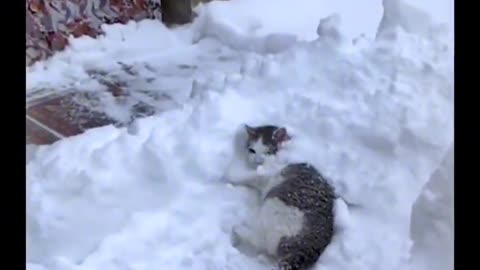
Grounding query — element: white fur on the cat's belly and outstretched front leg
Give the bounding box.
[226,158,304,256]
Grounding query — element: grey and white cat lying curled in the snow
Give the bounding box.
[225,125,336,270]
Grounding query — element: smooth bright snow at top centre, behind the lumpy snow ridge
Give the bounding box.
[198,0,383,40]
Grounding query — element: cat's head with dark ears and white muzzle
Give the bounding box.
[245,125,291,166]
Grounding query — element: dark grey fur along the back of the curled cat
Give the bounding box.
[265,163,335,270]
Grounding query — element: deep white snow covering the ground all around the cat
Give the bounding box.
[27,0,453,270]
